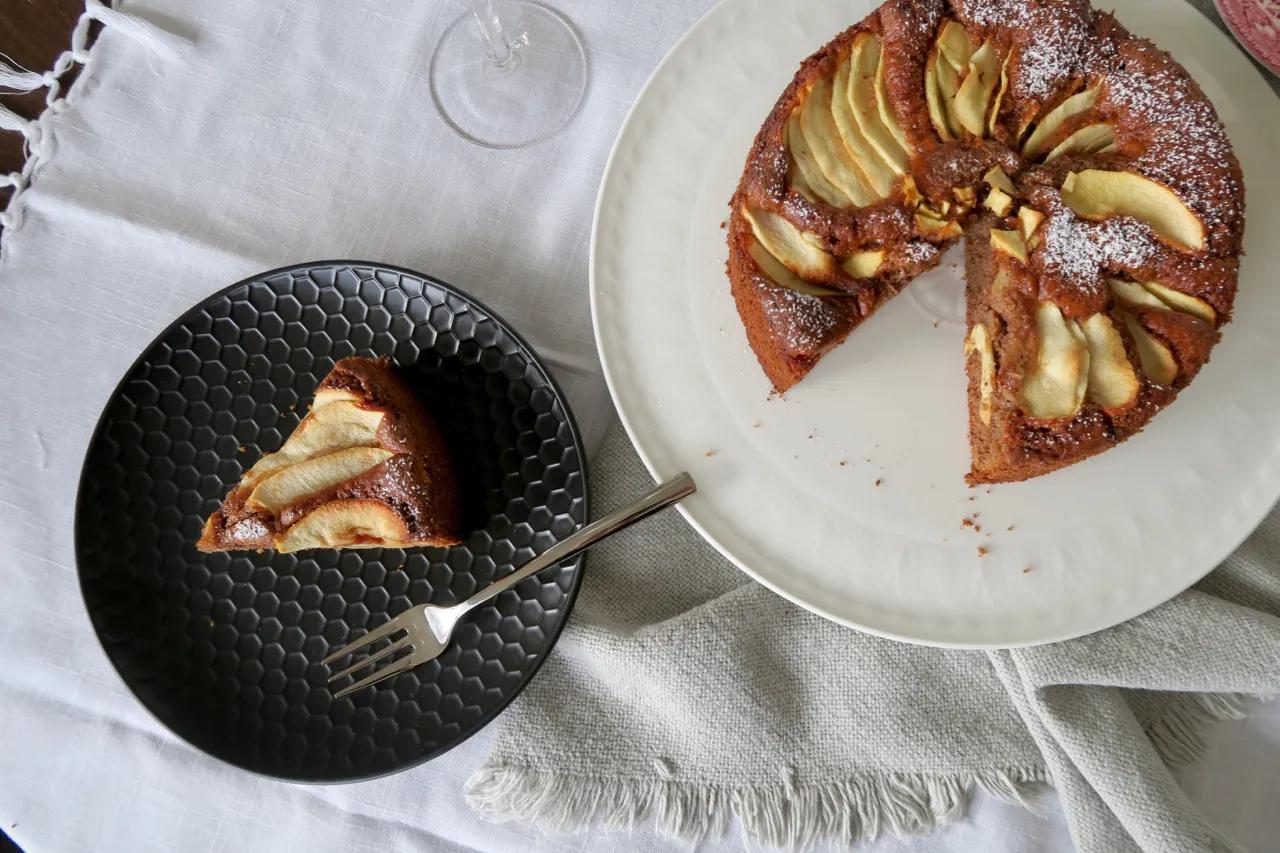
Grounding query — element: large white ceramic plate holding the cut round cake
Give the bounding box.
[591,0,1280,647]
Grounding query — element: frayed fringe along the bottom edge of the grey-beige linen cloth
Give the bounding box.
[467,762,1047,849]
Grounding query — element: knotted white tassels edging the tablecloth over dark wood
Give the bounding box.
[0,0,191,236]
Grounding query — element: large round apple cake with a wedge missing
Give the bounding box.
[727,0,1244,483]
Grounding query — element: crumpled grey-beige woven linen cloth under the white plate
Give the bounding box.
[470,429,1280,850]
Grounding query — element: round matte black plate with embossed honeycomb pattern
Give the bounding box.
[76,261,588,781]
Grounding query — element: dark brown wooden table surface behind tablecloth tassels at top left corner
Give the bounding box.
[0,0,84,207]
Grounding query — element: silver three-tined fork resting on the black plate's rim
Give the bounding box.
[324,471,698,698]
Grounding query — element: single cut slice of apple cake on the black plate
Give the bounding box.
[197,359,461,552]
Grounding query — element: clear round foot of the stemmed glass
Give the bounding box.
[430,0,588,149]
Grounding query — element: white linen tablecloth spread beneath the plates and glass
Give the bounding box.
[0,0,1280,853]
